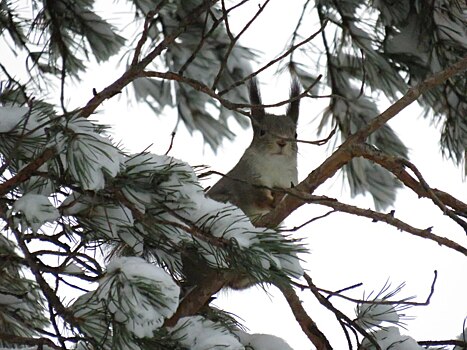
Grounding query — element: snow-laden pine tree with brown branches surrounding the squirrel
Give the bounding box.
[0,0,467,350]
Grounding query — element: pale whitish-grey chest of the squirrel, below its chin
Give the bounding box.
[254,155,298,188]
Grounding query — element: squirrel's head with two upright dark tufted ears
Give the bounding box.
[249,79,300,156]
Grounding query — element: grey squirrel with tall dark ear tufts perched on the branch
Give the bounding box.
[207,79,300,221]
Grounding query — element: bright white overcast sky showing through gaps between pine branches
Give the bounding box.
[1,1,467,350]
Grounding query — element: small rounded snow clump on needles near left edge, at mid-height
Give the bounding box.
[10,193,60,232]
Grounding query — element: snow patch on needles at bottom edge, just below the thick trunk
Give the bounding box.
[170,316,245,350]
